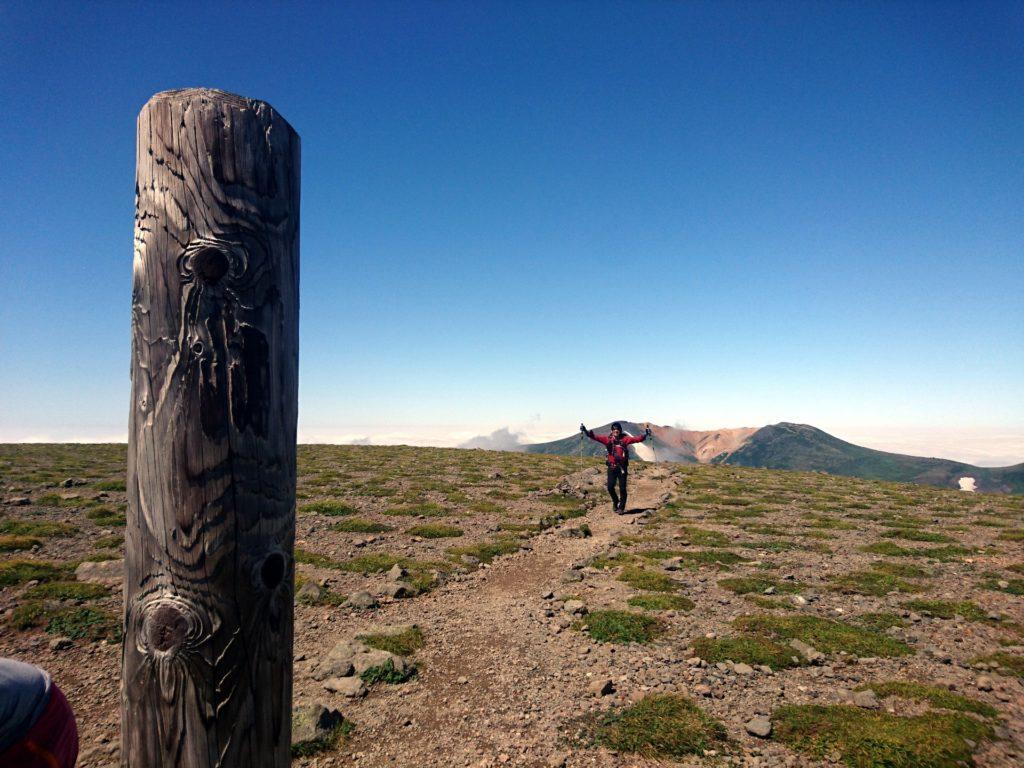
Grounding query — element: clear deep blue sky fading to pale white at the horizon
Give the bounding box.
[0,1,1024,463]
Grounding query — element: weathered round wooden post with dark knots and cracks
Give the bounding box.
[121,88,299,768]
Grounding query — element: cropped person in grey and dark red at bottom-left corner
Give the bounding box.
[0,657,78,768]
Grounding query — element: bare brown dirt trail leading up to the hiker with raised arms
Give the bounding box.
[309,473,672,766]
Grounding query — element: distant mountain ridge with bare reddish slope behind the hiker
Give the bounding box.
[523,420,1024,494]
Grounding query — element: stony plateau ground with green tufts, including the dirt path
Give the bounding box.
[0,445,1024,768]
